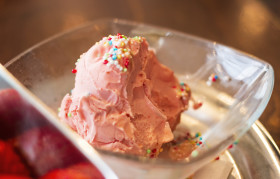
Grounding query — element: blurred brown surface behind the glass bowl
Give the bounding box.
[0,0,280,146]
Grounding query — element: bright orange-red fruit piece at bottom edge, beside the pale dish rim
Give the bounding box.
[40,163,104,179]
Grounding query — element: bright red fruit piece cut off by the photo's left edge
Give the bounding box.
[0,140,29,178]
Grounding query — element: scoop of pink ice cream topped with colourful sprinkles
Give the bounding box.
[59,34,190,156]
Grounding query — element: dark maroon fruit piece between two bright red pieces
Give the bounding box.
[17,126,87,176]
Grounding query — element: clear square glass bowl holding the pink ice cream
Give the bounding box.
[5,19,274,178]
